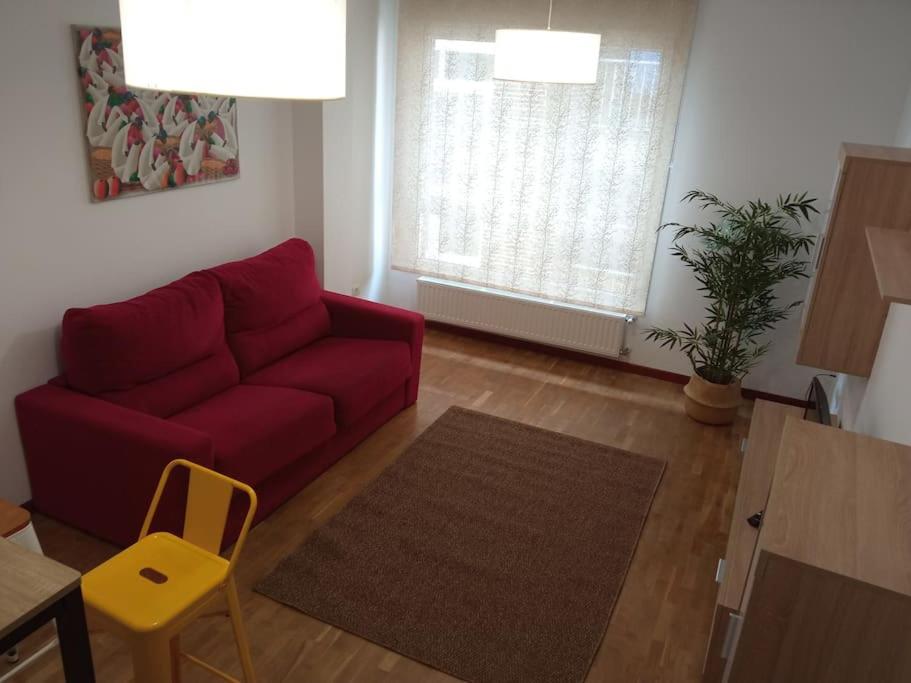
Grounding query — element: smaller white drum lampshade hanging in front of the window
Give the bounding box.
[493,28,601,84]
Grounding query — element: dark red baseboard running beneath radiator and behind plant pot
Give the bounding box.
[424,320,807,408]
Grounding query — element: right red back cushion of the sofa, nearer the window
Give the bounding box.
[209,239,329,375]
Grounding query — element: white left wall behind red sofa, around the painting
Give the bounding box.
[0,0,294,502]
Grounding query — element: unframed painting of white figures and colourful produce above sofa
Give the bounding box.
[73,27,240,202]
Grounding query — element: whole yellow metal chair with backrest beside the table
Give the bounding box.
[82,460,256,683]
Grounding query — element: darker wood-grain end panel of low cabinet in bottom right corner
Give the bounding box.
[728,550,911,683]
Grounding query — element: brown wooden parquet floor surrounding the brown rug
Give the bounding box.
[8,331,750,683]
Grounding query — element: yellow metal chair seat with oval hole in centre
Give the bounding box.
[82,533,228,633]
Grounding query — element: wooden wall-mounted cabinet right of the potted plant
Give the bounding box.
[797,143,911,377]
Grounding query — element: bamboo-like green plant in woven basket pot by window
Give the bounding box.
[646,190,819,424]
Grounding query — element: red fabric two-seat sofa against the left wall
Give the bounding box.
[16,239,424,545]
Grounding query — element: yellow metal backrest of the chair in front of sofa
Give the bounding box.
[139,459,256,574]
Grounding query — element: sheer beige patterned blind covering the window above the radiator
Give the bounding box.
[392,0,696,314]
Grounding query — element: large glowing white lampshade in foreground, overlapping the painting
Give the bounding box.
[120,0,345,100]
